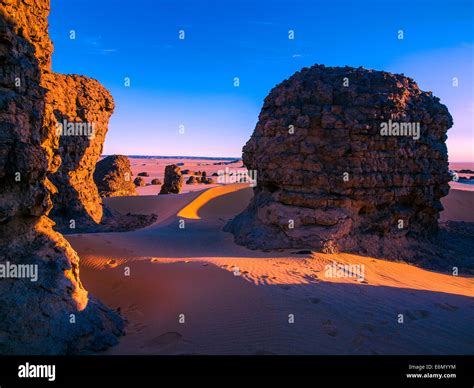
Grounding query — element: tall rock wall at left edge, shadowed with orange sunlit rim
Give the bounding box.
[0,0,123,354]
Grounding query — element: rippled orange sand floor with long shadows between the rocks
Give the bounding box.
[67,164,474,354]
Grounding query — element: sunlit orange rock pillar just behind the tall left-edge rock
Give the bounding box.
[45,73,114,230]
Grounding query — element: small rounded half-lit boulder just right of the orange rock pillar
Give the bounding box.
[94,155,137,197]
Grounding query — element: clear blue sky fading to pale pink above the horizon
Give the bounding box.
[49,0,474,162]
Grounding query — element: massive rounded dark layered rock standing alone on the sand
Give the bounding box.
[226,65,452,257]
